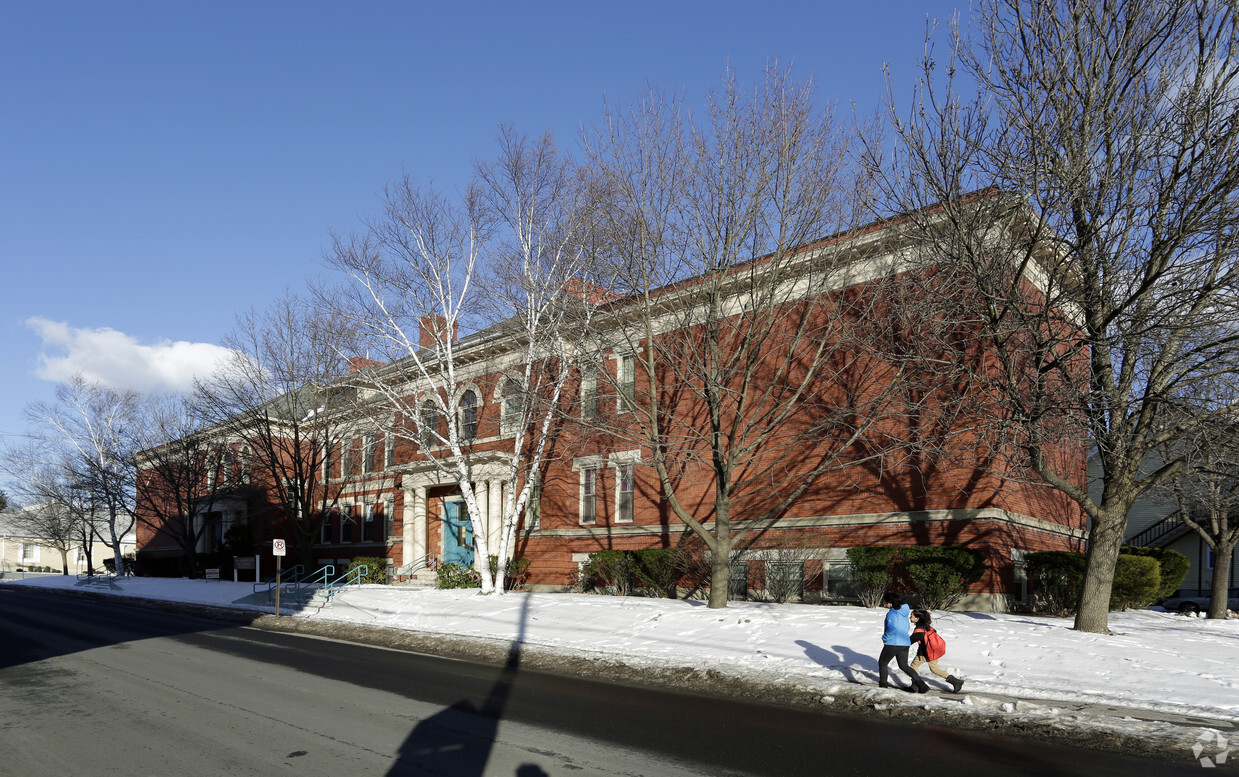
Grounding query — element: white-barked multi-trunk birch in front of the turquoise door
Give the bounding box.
[328,126,592,594]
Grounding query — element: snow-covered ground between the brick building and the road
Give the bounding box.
[0,575,1239,765]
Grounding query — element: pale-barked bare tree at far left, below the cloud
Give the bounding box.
[19,374,142,571]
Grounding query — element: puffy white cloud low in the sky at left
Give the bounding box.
[26,316,229,392]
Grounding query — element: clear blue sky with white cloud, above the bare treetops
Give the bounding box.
[0,0,966,493]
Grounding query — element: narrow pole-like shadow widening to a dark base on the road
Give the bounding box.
[387,597,546,777]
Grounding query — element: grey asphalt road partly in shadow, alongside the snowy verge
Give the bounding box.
[0,586,1199,777]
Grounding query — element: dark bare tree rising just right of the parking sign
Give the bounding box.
[195,294,370,564]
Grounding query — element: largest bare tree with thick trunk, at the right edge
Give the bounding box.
[871,0,1239,632]
